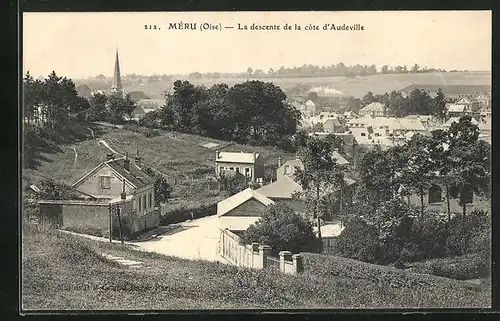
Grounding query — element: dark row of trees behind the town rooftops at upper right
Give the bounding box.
[347,89,446,120]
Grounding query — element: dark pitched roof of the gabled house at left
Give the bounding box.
[72,157,154,188]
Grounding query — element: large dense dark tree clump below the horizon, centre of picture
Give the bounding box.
[141,80,300,147]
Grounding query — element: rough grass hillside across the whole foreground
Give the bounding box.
[21,224,491,310]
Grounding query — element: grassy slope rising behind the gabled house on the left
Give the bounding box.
[23,127,292,198]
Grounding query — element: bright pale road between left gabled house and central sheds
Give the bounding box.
[135,216,227,263]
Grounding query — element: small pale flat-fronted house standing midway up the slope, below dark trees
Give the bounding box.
[215,150,264,182]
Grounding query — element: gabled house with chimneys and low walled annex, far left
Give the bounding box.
[38,153,160,235]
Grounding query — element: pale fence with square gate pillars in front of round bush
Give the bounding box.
[220,229,303,274]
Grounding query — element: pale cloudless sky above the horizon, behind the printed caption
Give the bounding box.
[23,11,492,78]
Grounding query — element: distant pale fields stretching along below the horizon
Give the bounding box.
[75,72,491,99]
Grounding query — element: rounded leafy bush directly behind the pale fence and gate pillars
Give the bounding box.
[242,203,317,255]
